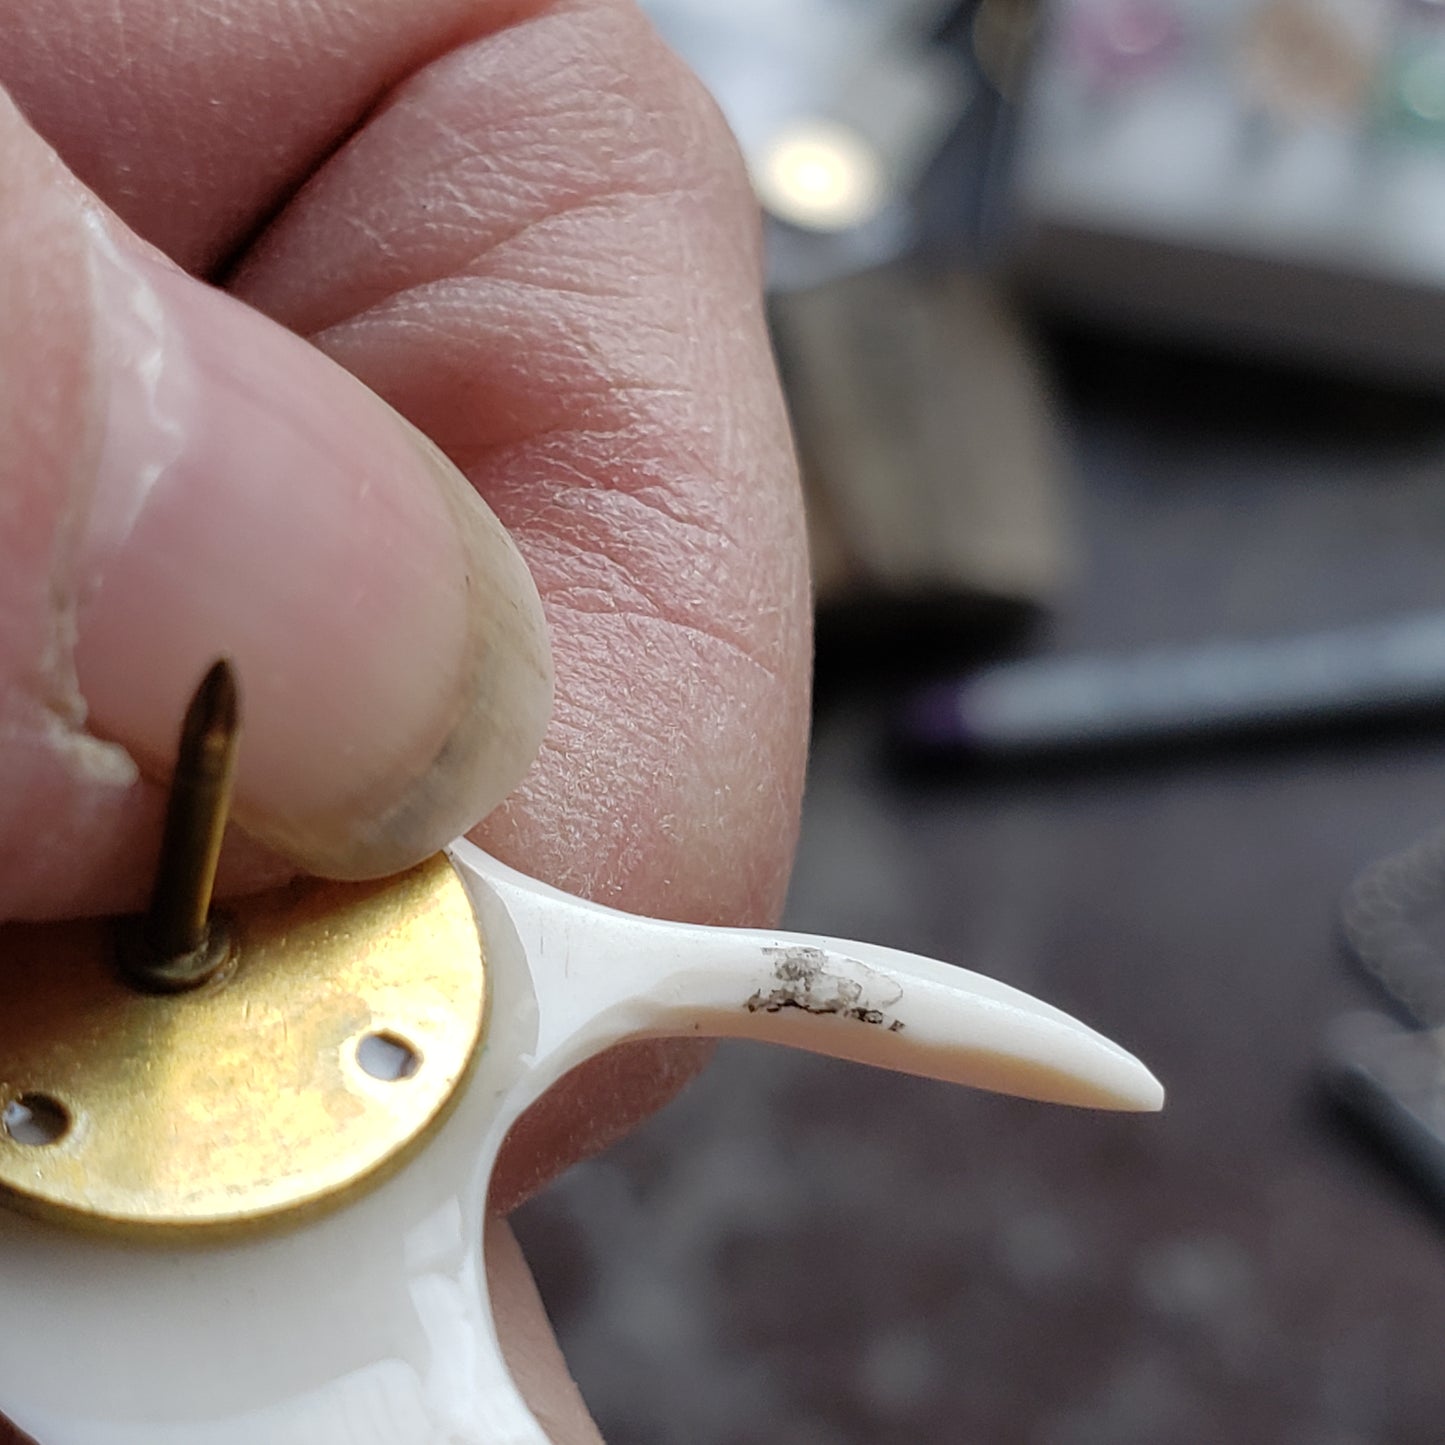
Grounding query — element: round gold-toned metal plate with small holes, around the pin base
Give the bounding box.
[0,854,487,1238]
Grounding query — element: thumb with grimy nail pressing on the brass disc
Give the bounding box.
[0,94,551,918]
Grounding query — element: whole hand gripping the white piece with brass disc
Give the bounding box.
[0,0,808,1445]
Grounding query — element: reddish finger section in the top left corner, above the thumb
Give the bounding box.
[0,0,508,275]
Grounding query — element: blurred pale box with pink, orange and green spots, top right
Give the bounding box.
[1005,0,1445,386]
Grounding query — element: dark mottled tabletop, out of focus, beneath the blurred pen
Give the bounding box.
[519,330,1445,1445]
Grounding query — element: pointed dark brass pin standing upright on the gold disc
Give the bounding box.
[121,657,240,993]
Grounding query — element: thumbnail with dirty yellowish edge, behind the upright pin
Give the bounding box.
[67,223,552,877]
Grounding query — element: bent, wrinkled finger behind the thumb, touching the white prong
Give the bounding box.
[225,6,808,1207]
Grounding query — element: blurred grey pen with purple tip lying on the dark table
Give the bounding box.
[900,613,1445,756]
